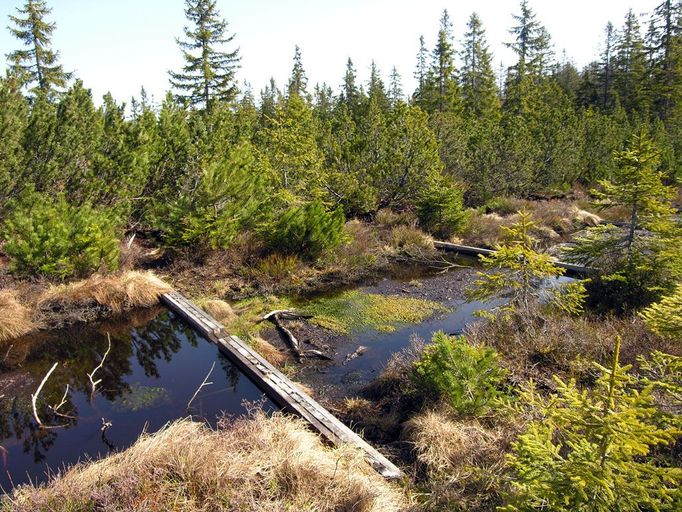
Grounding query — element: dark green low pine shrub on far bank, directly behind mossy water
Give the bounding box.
[265,201,345,260]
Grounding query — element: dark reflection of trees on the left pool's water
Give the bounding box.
[0,308,194,463]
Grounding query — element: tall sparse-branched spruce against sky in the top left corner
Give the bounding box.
[7,0,71,93]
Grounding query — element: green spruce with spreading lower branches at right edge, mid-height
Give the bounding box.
[566,131,682,310]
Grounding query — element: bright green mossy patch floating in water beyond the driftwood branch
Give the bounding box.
[303,290,447,334]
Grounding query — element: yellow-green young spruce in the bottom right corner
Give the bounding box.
[500,338,682,512]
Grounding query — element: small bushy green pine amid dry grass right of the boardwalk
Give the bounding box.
[414,331,506,415]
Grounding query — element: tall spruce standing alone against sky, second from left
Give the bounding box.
[169,0,240,109]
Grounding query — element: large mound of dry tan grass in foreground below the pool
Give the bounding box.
[5,413,407,512]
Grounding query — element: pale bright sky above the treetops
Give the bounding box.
[0,0,661,106]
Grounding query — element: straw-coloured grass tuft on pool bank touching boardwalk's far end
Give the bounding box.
[39,271,171,314]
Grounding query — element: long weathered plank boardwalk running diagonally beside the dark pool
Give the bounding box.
[161,292,403,479]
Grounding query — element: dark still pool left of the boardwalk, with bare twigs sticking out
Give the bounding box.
[0,308,275,491]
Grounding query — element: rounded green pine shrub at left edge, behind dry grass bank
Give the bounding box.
[0,189,120,279]
